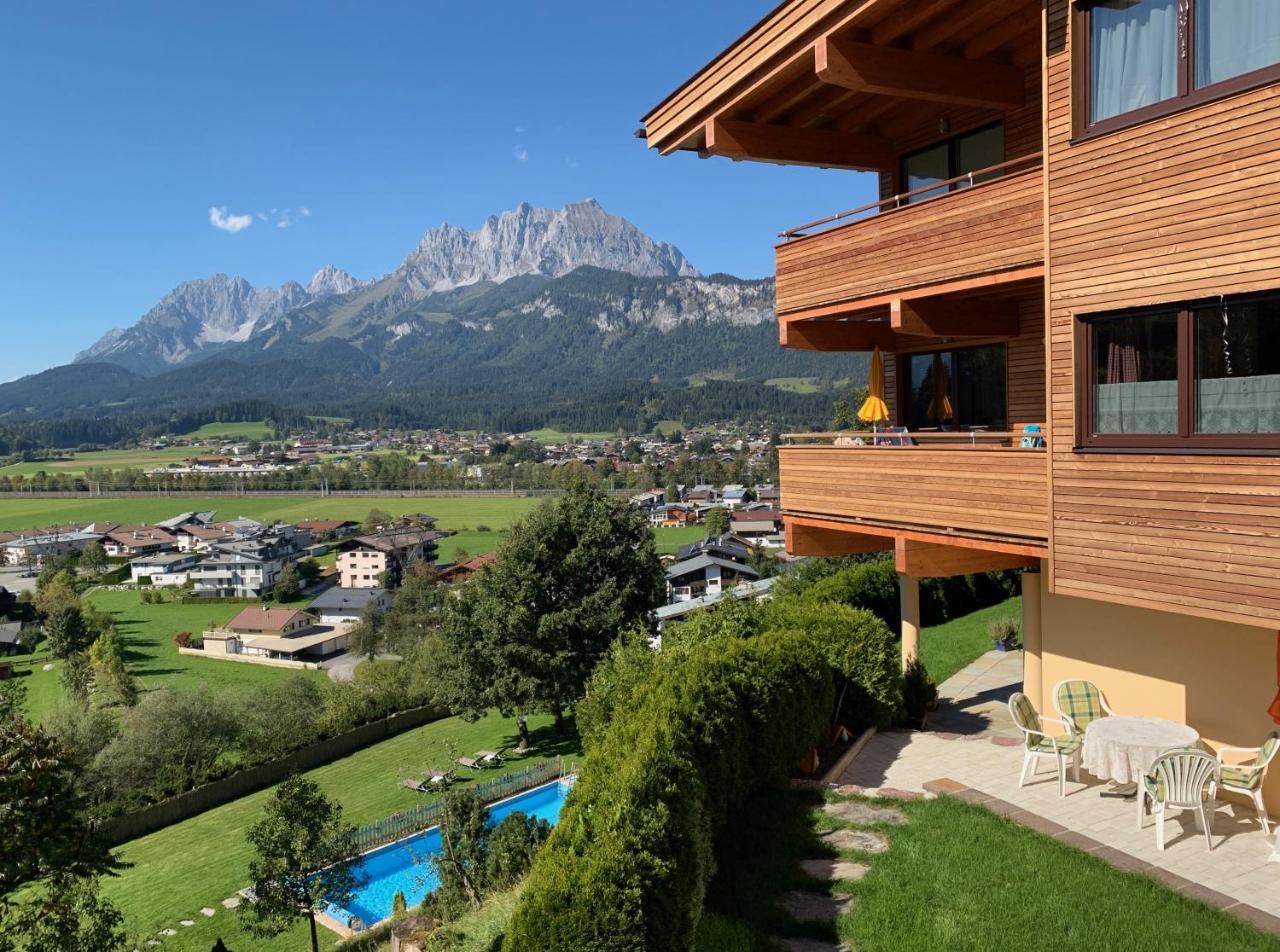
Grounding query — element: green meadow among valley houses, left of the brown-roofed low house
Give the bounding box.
[19,591,325,720]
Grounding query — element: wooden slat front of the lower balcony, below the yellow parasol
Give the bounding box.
[778,445,1048,543]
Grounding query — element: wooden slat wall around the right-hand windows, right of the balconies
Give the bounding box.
[1046,0,1280,628]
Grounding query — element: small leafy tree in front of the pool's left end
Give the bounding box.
[241,777,360,952]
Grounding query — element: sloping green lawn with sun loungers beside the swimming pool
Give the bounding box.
[104,714,579,952]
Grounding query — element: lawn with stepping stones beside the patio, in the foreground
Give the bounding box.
[696,791,1280,952]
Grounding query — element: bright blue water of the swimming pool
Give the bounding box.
[325,781,571,926]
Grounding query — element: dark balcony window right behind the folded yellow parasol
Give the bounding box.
[902,344,1009,431]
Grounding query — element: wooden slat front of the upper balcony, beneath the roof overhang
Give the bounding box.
[777,169,1043,313]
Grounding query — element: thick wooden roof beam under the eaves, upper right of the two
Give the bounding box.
[814,36,1027,109]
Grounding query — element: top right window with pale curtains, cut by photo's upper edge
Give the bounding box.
[1075,0,1280,132]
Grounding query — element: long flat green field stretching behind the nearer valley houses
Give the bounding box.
[0,493,541,528]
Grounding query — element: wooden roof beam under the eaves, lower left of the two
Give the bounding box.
[707,119,897,171]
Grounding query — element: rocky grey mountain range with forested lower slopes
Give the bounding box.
[0,200,850,425]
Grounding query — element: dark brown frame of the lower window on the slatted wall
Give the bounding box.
[1075,290,1280,454]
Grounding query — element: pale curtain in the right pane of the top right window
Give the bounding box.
[1196,0,1280,87]
